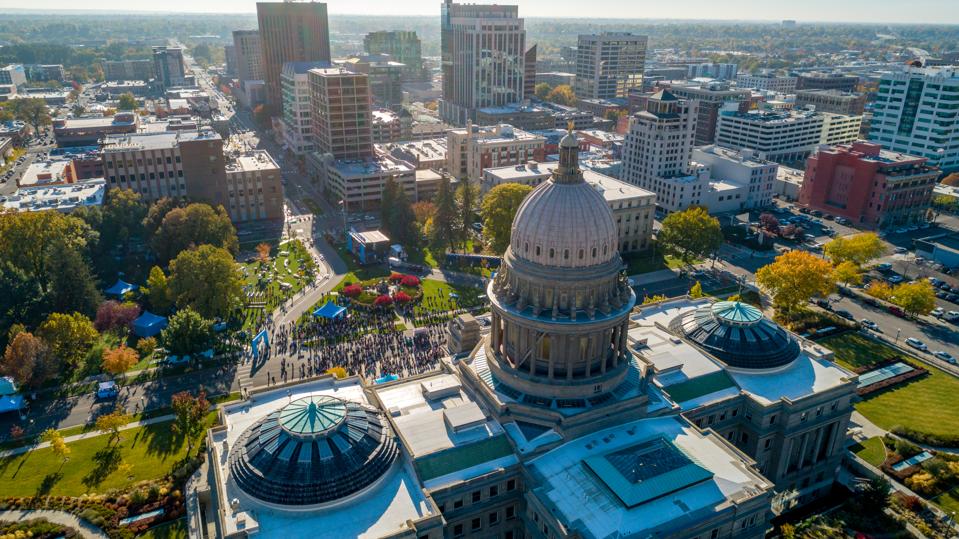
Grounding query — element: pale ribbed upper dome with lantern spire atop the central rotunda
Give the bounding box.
[510,133,618,268]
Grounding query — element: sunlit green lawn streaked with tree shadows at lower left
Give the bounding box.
[0,412,216,497]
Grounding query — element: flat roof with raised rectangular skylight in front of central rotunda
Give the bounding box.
[530,417,772,537]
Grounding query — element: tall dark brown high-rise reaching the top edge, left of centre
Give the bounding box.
[256,2,330,112]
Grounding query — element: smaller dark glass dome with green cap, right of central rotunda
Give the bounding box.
[670,301,800,369]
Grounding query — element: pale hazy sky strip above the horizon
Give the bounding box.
[0,0,959,24]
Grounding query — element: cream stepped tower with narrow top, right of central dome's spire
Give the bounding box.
[622,90,698,194]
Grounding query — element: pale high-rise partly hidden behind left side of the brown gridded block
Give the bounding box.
[280,62,329,155]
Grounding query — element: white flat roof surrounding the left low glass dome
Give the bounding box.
[212,378,437,539]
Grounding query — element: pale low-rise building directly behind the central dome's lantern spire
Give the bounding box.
[480,162,656,252]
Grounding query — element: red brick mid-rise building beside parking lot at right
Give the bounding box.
[799,141,940,228]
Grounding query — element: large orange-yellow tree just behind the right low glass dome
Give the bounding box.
[756,250,835,312]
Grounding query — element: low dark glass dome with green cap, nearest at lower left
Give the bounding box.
[230,395,398,506]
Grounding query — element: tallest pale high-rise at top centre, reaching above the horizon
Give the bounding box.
[439,0,526,126]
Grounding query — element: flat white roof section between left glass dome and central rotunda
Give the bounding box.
[374,373,518,488]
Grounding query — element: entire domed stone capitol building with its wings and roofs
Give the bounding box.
[188,133,857,539]
